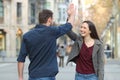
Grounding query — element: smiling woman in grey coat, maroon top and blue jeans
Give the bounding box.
[67,20,104,80]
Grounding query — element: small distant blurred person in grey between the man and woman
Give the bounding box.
[58,44,66,67]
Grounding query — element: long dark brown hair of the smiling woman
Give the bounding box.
[82,20,100,40]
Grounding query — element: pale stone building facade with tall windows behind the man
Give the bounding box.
[0,0,68,57]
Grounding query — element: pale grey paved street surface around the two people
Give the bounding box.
[0,58,120,80]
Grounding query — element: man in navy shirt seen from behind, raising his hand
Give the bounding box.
[17,4,75,80]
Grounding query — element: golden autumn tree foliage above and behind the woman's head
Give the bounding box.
[88,0,113,35]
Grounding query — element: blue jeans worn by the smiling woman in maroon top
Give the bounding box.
[75,72,98,80]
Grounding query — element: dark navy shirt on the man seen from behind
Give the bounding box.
[18,23,72,77]
